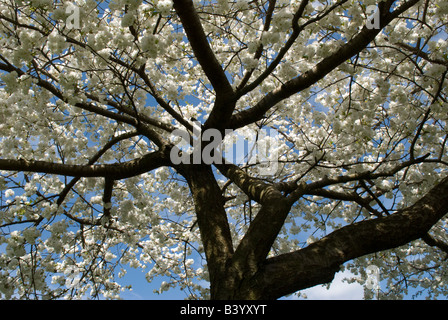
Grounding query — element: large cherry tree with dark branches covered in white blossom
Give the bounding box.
[0,0,448,299]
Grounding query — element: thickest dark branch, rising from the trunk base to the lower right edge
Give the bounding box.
[247,178,448,299]
